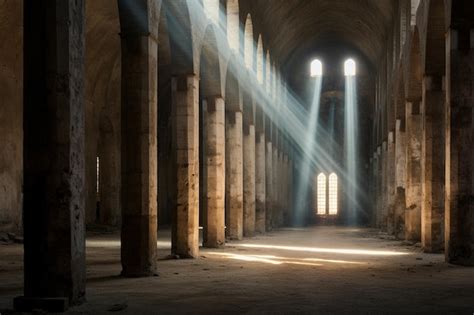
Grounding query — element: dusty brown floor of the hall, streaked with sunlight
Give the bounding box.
[0,227,474,314]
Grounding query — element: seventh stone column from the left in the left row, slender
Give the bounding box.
[255,131,266,233]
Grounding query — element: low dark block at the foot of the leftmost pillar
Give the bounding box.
[13,296,69,313]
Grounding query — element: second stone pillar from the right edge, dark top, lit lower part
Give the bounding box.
[421,77,446,253]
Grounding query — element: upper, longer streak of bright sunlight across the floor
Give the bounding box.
[234,244,407,256]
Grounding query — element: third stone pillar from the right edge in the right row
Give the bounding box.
[405,102,422,242]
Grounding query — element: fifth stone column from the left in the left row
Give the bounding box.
[225,112,244,240]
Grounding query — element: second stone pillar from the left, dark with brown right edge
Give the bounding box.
[121,29,158,277]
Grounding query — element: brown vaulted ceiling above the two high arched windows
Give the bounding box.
[241,0,398,71]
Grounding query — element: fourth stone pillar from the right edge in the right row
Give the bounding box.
[394,119,407,239]
